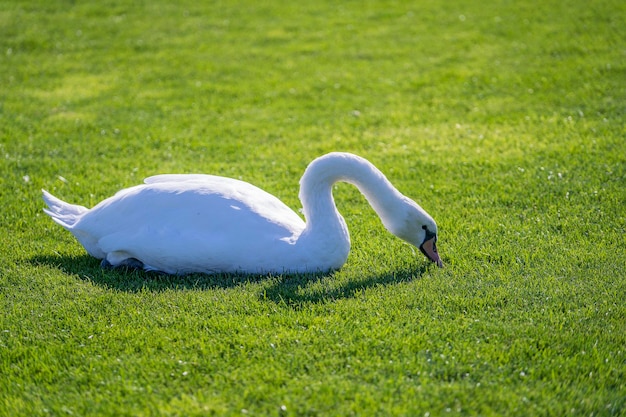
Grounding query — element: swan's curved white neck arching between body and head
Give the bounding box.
[300,153,403,240]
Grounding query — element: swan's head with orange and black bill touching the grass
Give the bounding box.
[385,197,443,267]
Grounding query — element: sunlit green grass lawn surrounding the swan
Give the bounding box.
[0,0,626,416]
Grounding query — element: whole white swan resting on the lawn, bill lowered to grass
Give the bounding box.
[42,153,442,274]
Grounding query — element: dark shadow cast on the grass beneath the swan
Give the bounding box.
[30,254,427,305]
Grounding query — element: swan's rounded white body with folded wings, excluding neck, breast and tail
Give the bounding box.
[71,175,305,273]
